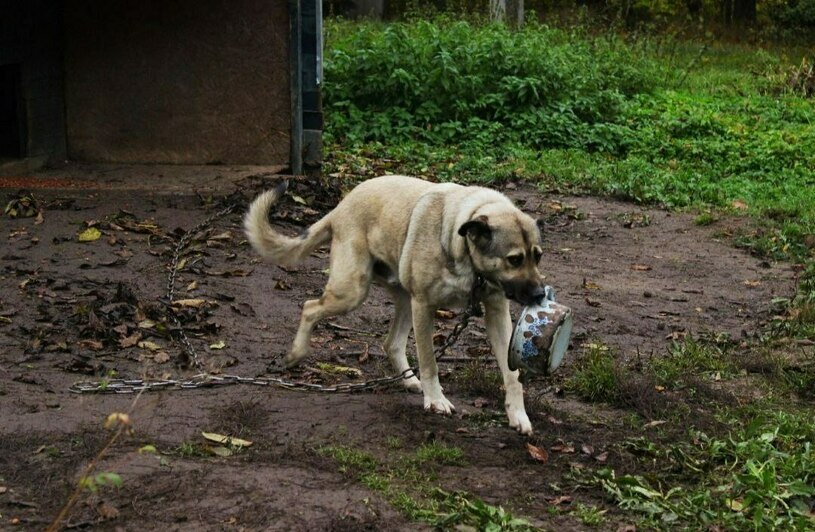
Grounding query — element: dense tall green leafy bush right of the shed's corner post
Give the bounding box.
[324,19,654,153]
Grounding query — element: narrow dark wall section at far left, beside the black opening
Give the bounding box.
[0,0,65,168]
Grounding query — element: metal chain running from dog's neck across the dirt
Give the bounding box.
[69,195,484,394]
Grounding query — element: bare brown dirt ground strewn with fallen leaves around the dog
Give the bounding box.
[0,167,794,530]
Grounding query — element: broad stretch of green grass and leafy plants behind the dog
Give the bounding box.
[324,18,815,260]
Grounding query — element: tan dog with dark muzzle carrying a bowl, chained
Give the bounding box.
[244,176,544,435]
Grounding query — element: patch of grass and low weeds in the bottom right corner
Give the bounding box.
[588,404,815,530]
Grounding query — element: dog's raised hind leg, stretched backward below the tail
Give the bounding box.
[284,237,373,367]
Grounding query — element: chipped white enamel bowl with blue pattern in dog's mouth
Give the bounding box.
[509,286,572,375]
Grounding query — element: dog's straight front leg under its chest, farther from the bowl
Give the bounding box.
[411,299,455,414]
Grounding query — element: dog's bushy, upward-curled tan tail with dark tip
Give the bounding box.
[243,181,331,266]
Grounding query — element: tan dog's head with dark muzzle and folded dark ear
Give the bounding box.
[458,209,545,305]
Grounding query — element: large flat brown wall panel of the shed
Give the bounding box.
[64,0,291,164]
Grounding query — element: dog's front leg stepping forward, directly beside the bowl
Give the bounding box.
[484,294,532,436]
